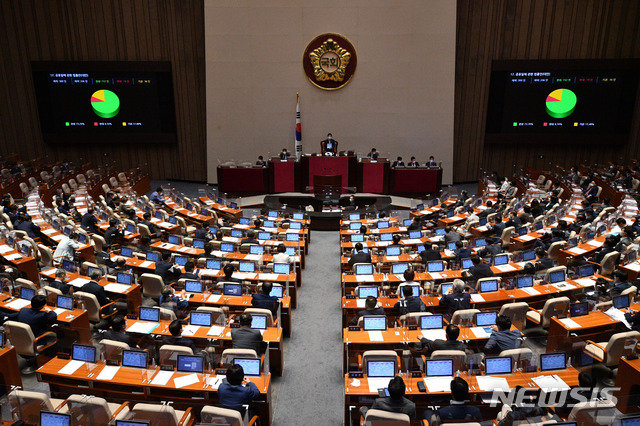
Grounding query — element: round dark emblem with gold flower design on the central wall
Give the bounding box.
[302,33,358,90]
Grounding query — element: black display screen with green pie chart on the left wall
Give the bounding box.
[32,62,176,143]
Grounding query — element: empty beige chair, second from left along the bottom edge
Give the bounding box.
[66,394,129,425]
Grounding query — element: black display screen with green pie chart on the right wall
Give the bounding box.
[486,60,640,143]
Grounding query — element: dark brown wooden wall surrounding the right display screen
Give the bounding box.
[453,0,640,182]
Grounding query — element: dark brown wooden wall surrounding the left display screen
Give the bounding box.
[0,0,207,181]
